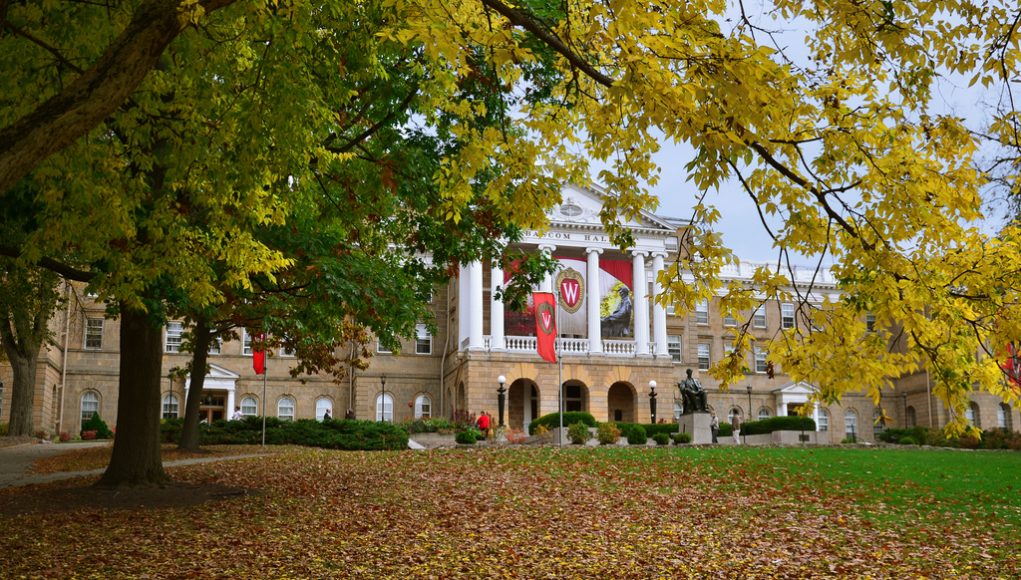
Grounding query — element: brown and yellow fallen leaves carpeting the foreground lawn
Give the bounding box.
[0,448,1021,578]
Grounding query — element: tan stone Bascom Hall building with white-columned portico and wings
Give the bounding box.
[0,186,1021,443]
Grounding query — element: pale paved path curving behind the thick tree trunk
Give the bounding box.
[0,441,262,489]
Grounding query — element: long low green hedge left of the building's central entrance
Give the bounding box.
[160,417,407,451]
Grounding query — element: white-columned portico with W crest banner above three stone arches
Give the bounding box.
[444,186,684,428]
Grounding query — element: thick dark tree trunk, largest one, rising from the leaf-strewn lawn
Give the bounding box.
[97,306,168,487]
